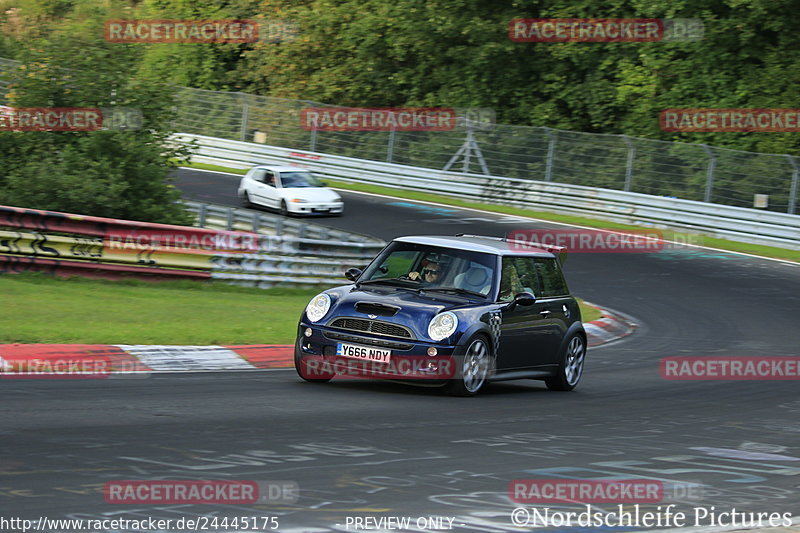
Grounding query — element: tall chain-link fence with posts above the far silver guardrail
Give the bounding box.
[0,59,800,214]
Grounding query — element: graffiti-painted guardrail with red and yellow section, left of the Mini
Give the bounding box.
[0,206,383,287]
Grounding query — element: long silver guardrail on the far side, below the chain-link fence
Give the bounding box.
[173,134,800,249]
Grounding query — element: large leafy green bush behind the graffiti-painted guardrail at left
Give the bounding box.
[0,6,194,224]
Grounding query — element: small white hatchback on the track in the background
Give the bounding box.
[239,165,344,215]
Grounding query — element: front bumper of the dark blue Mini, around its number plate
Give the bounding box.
[295,322,458,382]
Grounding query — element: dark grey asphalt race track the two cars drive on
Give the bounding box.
[0,170,800,533]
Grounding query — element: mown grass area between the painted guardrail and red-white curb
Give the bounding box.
[0,274,599,345]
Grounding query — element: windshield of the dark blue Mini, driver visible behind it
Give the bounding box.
[359,242,497,296]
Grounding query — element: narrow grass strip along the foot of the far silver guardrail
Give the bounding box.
[184,163,800,262]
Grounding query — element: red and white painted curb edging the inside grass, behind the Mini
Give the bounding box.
[0,308,636,377]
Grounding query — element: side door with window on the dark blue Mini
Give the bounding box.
[497,256,560,370]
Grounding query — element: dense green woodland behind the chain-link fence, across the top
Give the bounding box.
[0,0,800,218]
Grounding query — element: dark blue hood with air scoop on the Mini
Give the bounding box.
[325,285,475,338]
